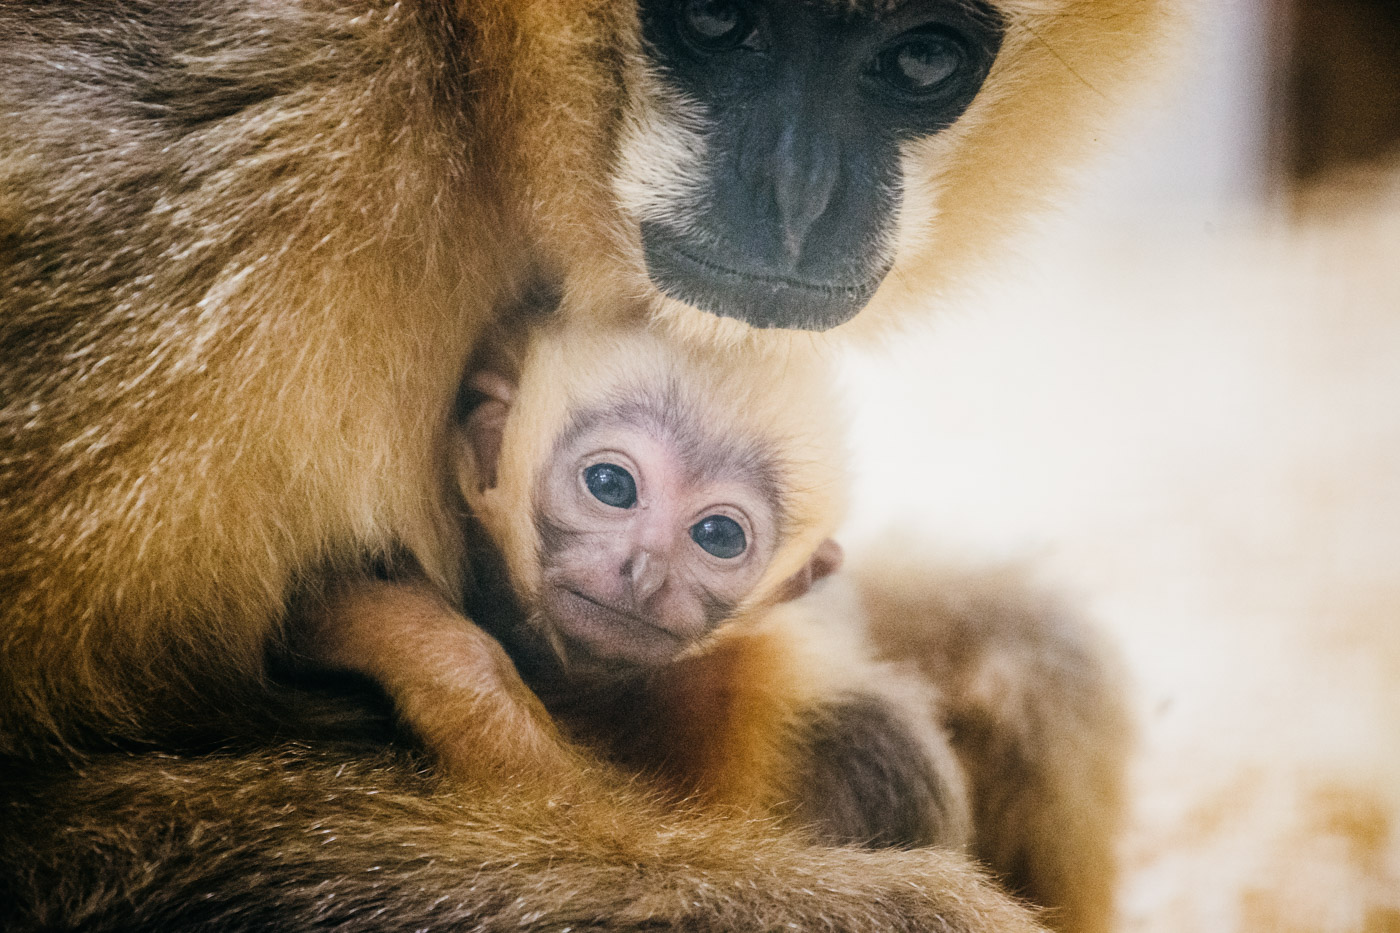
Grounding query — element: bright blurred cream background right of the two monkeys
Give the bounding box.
[846,0,1400,933]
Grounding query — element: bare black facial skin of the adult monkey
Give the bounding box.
[641,0,1004,331]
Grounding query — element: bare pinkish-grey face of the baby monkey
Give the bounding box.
[535,395,781,665]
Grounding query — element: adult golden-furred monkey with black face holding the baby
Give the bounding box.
[0,0,1168,930]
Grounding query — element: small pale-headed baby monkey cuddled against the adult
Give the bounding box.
[301,313,1127,930]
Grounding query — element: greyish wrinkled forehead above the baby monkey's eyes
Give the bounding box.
[550,380,787,520]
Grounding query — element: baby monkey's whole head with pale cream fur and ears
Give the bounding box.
[458,325,844,670]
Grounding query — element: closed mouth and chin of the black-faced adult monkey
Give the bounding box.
[641,223,893,331]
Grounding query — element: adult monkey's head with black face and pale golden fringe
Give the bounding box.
[520,0,1165,331]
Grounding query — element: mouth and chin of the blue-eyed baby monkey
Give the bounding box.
[543,586,689,665]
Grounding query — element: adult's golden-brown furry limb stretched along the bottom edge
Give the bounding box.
[0,745,1040,933]
